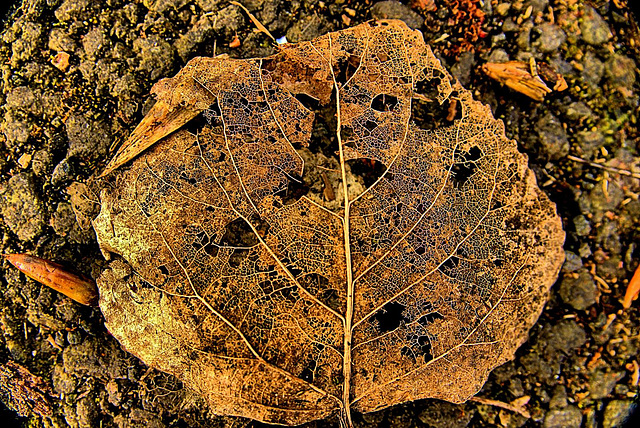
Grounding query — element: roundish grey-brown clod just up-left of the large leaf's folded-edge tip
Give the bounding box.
[65,114,111,161]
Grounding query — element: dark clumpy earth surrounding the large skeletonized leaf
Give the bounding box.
[0,0,640,428]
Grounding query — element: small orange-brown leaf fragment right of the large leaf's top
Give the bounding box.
[482,58,568,101]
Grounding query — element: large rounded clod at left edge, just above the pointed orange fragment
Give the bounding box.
[0,172,46,241]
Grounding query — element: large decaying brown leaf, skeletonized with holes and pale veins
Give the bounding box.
[94,21,564,425]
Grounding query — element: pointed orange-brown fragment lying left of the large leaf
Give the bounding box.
[4,254,98,306]
